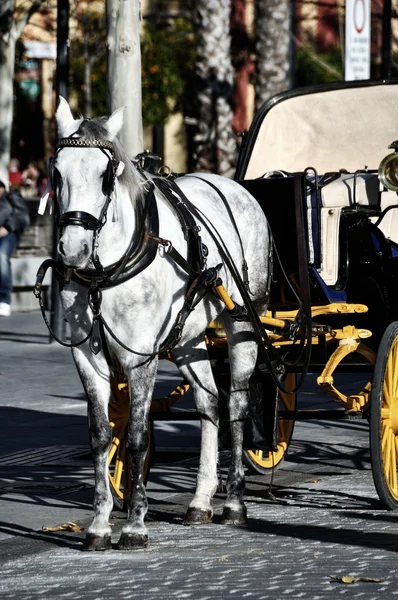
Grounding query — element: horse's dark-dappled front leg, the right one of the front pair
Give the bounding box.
[117,359,158,550]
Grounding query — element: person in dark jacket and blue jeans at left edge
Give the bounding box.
[0,181,30,317]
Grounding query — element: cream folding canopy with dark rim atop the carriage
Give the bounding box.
[244,84,398,179]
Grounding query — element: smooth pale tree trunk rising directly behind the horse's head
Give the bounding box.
[106,0,143,158]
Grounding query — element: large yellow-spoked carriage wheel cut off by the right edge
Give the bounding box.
[370,322,398,510]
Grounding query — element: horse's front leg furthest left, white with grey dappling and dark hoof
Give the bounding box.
[73,349,113,550]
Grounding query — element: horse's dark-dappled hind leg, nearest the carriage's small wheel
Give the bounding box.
[221,323,257,525]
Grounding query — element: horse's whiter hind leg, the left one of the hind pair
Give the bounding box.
[173,342,218,524]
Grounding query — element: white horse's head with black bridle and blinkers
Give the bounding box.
[50,97,124,268]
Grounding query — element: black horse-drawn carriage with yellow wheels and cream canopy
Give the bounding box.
[36,82,398,549]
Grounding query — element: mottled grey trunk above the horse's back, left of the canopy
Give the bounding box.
[194,0,237,177]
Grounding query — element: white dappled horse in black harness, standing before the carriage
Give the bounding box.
[51,99,269,550]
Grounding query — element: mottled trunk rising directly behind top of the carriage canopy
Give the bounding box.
[255,0,291,109]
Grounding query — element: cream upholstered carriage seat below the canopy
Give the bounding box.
[306,172,398,286]
